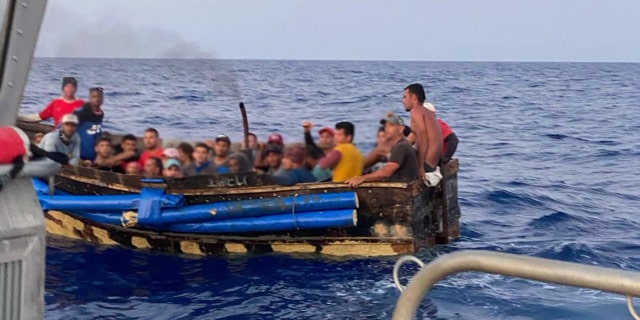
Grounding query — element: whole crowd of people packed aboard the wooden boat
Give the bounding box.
[19,77,458,187]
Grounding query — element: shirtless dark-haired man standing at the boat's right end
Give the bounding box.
[402,83,442,181]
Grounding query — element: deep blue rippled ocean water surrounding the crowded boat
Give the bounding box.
[22,59,640,319]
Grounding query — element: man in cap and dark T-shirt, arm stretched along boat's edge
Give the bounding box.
[345,114,418,188]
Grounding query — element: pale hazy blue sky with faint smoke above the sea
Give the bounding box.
[36,0,640,62]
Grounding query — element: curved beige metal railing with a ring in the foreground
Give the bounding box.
[393,250,640,319]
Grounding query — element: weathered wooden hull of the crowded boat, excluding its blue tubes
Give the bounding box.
[18,123,460,256]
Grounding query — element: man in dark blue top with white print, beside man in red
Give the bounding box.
[73,87,104,161]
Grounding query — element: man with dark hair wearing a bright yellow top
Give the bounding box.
[318,121,364,182]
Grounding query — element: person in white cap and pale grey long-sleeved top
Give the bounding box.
[38,114,80,165]
